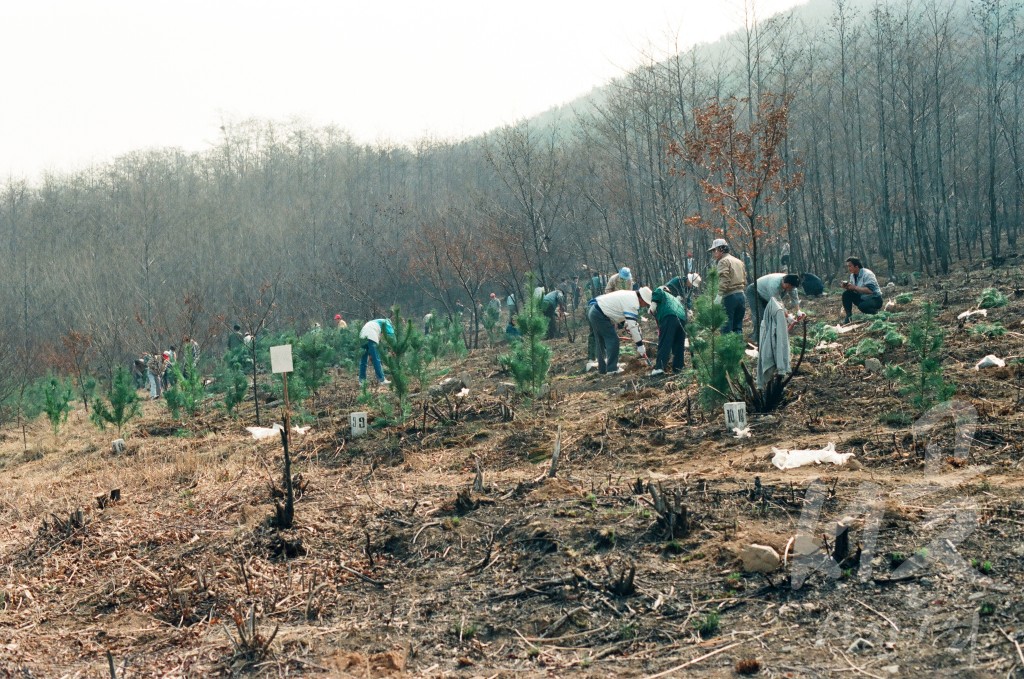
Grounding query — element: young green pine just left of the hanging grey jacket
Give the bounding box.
[687,269,745,410]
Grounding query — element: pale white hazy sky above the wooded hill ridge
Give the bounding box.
[0,0,800,182]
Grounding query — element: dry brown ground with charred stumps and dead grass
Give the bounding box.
[0,260,1024,677]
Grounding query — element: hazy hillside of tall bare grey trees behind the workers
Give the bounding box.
[0,0,1024,387]
